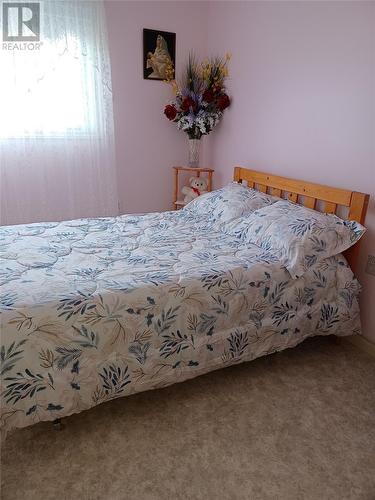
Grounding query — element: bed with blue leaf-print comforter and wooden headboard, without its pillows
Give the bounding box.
[0,167,368,432]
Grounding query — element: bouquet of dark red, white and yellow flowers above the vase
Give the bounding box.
[164,54,230,139]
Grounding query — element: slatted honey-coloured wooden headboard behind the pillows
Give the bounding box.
[234,167,370,271]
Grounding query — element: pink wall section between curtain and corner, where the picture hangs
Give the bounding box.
[105,0,208,213]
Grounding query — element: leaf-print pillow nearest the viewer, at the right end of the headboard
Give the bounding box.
[221,200,366,278]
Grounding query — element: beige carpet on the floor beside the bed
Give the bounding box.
[1,339,375,500]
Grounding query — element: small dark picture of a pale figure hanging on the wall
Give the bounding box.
[143,29,176,80]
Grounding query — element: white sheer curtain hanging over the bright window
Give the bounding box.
[0,0,118,224]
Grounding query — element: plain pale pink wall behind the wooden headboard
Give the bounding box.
[208,2,375,342]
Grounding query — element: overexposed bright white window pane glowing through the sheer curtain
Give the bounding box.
[0,39,89,138]
